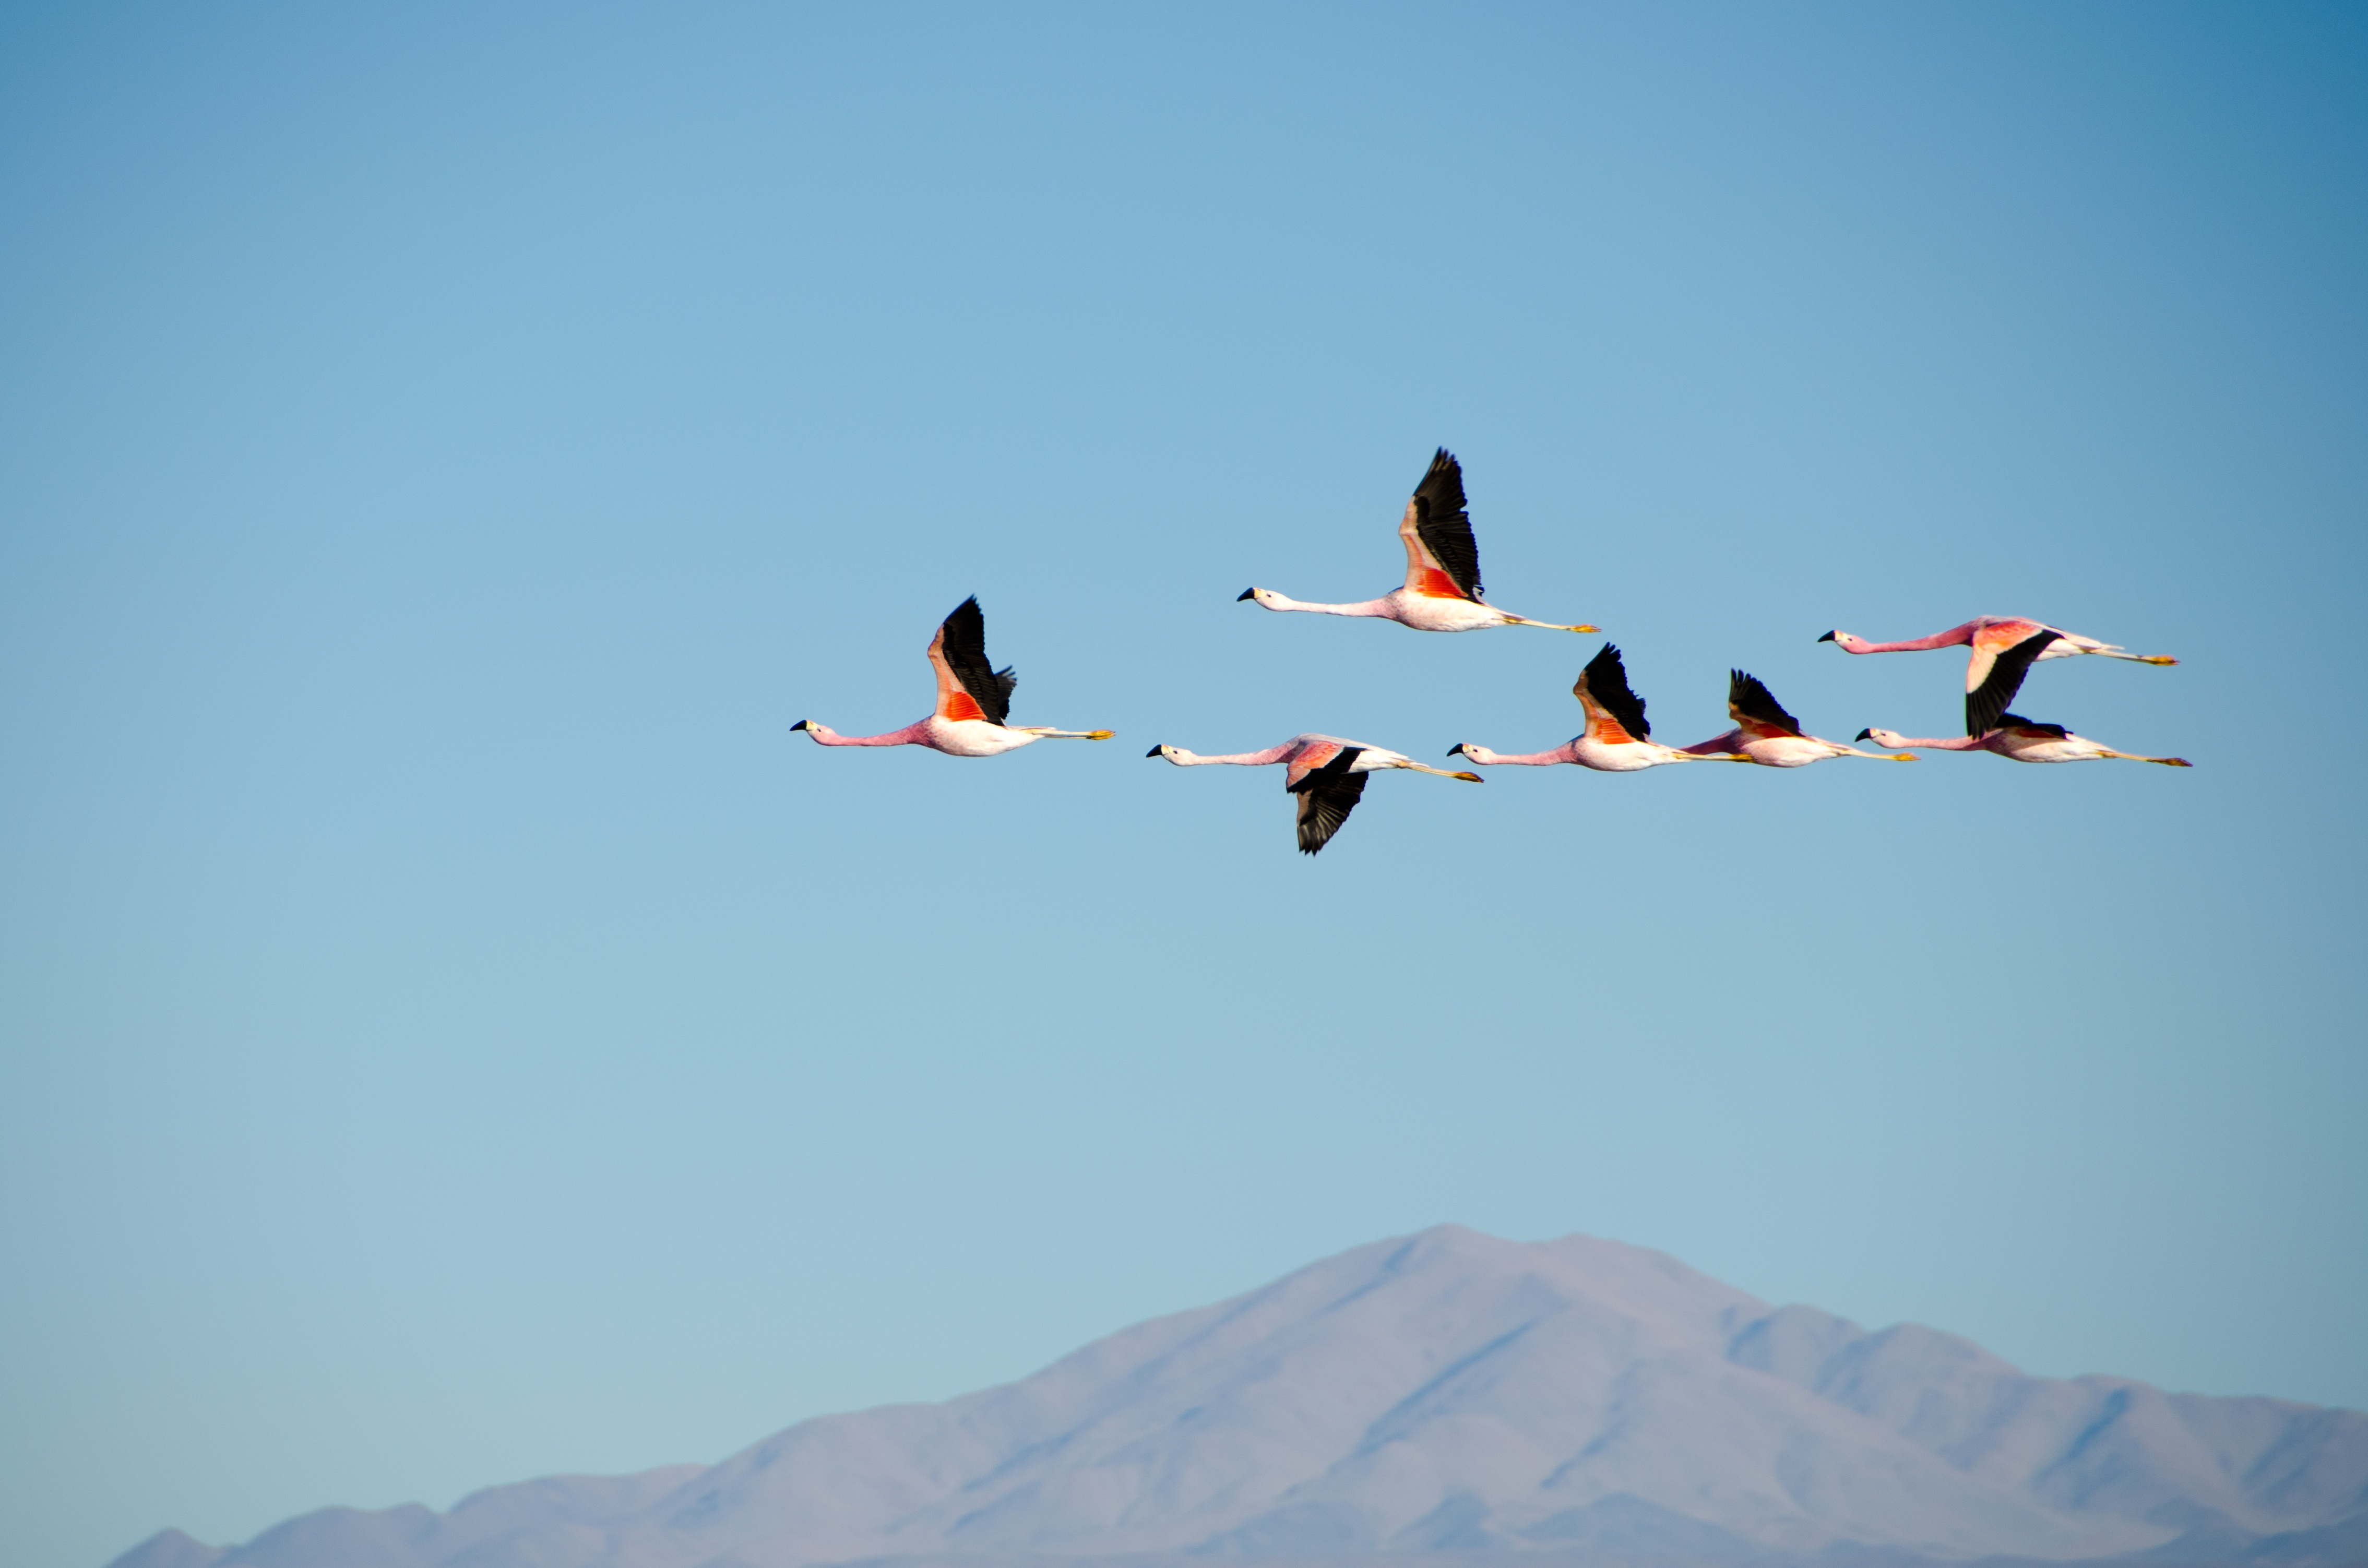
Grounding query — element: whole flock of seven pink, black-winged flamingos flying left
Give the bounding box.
[791,448,2191,855]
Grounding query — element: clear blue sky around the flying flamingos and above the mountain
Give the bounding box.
[0,5,2368,1568]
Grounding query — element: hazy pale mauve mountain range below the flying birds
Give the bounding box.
[116,1227,2368,1568]
